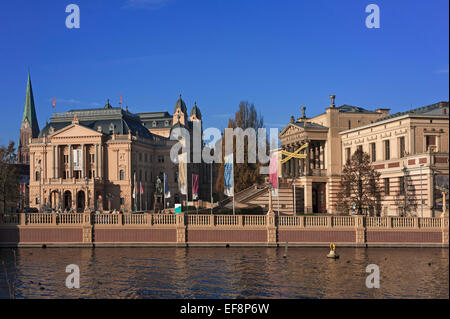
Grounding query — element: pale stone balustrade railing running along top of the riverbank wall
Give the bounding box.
[0,213,443,229]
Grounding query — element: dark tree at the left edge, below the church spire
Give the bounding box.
[0,142,19,209]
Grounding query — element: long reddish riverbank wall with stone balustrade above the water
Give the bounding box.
[0,213,449,247]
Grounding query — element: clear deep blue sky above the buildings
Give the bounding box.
[0,0,449,144]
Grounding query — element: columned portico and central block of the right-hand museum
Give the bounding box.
[279,95,389,214]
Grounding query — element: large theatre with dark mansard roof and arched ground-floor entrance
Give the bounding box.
[29,96,209,211]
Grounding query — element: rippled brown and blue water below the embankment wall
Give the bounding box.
[0,247,449,298]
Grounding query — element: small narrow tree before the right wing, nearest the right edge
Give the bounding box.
[395,169,417,217]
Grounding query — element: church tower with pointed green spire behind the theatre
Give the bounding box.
[17,73,39,164]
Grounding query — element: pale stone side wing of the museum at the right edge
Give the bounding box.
[339,102,449,217]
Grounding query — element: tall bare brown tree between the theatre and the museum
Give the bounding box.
[216,101,264,193]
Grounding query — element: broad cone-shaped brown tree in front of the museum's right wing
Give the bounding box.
[336,149,382,215]
